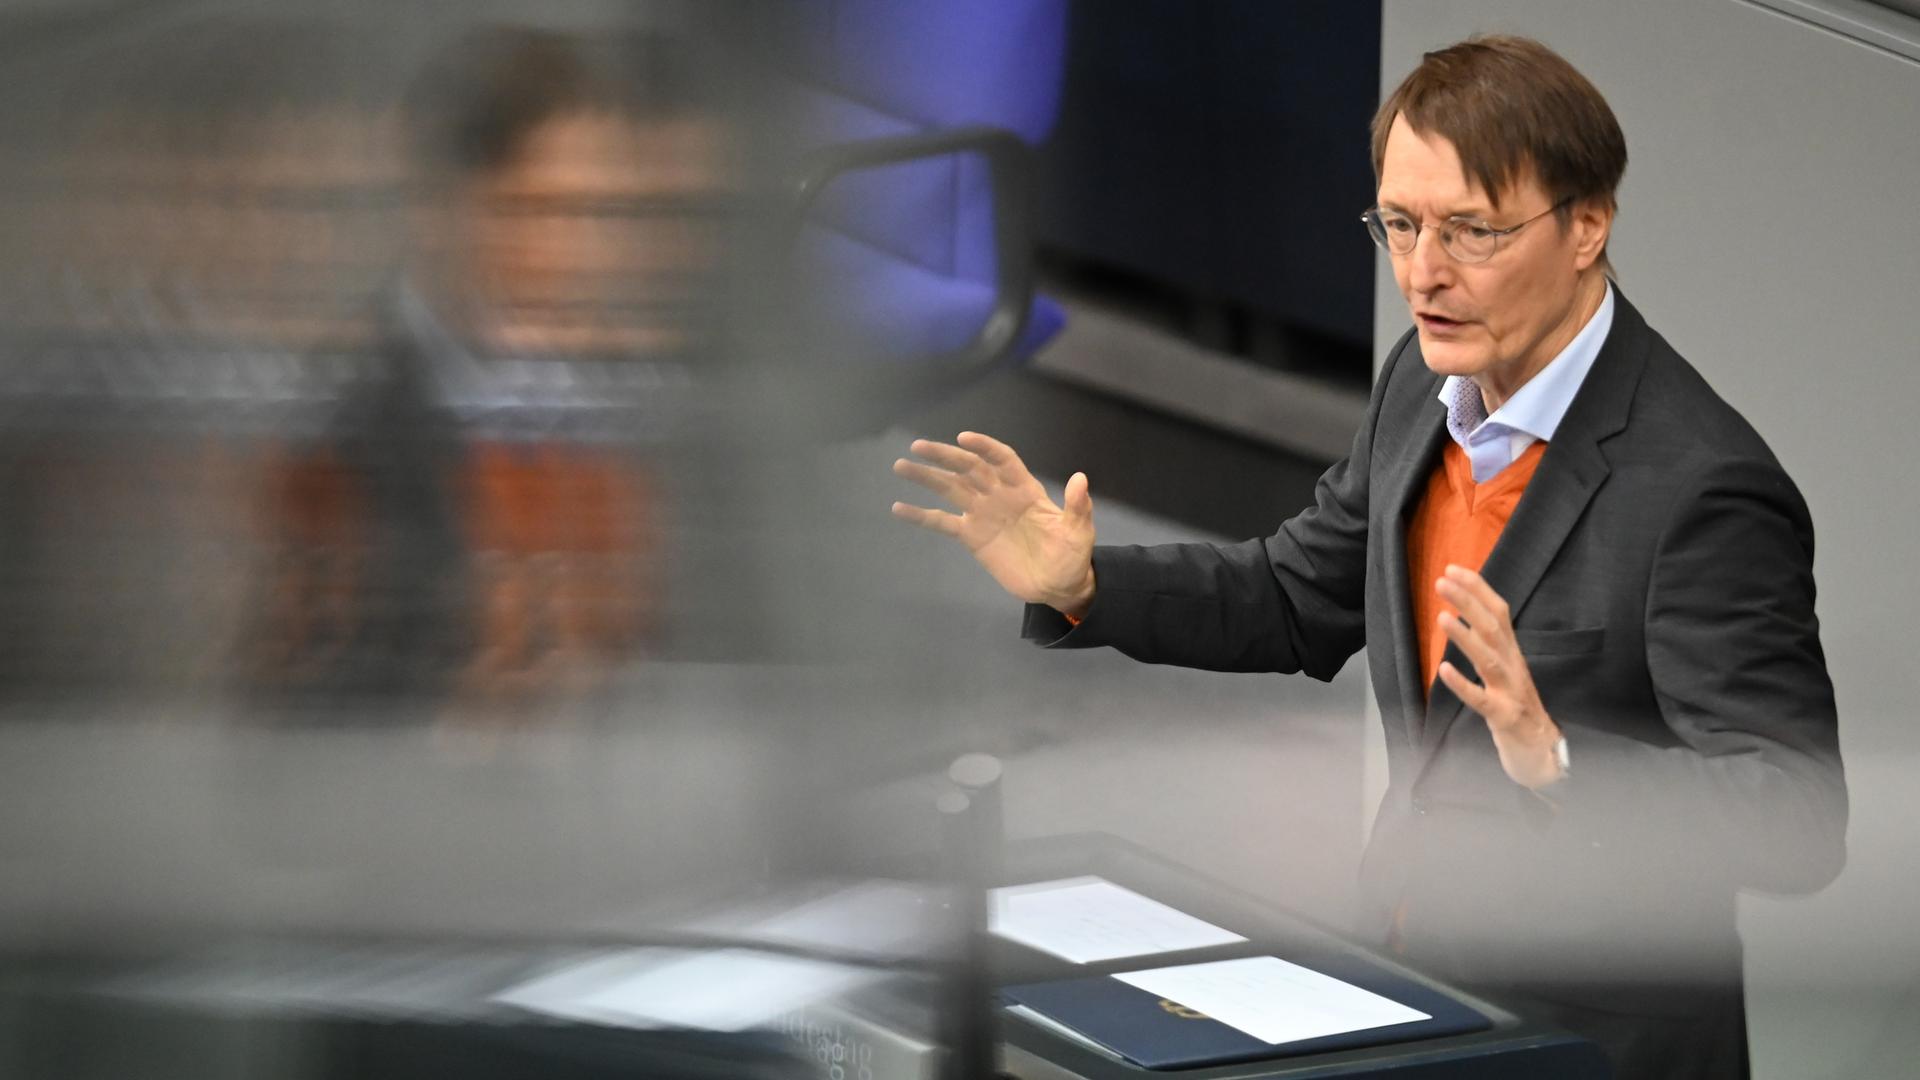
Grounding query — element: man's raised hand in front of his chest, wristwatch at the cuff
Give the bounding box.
[1434,565,1561,790]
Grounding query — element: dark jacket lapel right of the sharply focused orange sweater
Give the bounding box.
[1402,290,1647,765]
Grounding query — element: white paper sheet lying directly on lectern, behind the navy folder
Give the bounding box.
[989,878,1246,963]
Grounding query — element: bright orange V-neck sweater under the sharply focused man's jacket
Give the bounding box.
[1407,442,1548,692]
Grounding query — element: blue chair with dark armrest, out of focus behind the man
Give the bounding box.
[785,0,1068,384]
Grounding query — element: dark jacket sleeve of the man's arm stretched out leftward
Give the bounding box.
[1023,332,1413,678]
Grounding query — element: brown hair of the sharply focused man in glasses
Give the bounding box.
[1373,35,1626,271]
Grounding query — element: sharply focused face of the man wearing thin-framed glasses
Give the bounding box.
[1379,115,1611,399]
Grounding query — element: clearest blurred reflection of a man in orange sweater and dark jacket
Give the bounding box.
[255,27,728,719]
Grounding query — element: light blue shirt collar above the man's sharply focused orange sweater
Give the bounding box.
[1440,282,1613,484]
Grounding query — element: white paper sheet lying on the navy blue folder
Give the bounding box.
[1114,957,1430,1043]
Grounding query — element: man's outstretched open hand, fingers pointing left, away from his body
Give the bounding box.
[893,430,1094,619]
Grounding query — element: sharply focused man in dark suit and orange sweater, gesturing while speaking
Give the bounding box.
[895,38,1847,1076]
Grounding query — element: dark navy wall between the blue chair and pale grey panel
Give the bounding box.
[1039,0,1380,368]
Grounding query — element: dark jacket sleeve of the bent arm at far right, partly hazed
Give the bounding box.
[1548,445,1847,892]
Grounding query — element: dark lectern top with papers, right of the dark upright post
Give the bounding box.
[991,834,1611,1080]
